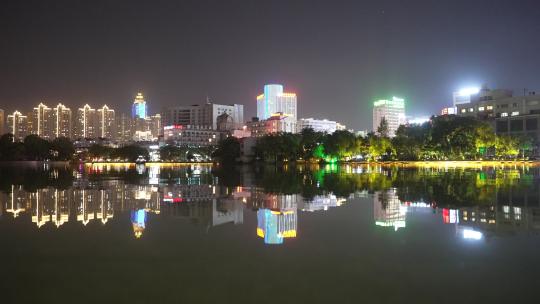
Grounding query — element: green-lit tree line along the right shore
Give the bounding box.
[215,115,535,163]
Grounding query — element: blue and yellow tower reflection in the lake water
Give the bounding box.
[257,209,298,244]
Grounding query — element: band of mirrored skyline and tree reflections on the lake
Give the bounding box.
[0,165,540,244]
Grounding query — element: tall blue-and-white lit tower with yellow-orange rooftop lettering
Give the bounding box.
[257,84,297,120]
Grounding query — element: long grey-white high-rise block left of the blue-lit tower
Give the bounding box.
[162,103,244,130]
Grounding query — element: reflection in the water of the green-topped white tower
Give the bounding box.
[373,188,407,231]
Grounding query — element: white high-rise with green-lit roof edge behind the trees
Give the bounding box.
[373,96,406,137]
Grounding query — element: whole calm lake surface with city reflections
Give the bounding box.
[0,166,540,303]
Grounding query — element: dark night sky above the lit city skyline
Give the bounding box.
[0,0,540,130]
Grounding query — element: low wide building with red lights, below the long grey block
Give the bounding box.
[163,125,222,147]
